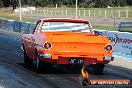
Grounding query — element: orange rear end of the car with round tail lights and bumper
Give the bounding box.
[39,32,113,65]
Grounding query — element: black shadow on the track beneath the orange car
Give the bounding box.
[17,63,82,74]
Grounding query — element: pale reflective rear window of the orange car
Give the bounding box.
[42,22,89,32]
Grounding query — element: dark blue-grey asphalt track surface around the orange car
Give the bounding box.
[0,31,132,88]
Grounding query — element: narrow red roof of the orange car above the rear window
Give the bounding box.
[41,18,90,23]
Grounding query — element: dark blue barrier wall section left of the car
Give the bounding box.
[0,19,35,33]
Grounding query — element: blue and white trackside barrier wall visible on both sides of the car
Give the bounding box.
[0,19,132,55]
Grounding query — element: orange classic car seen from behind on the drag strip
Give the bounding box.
[22,18,114,73]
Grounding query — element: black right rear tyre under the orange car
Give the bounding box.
[90,64,105,74]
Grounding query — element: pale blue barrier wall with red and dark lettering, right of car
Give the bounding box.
[94,29,132,55]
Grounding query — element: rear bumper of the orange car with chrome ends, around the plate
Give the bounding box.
[39,54,114,65]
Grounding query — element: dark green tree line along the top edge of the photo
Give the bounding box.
[0,0,132,9]
